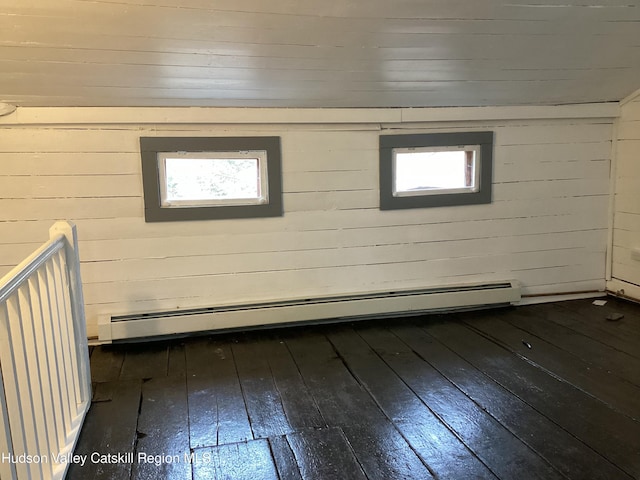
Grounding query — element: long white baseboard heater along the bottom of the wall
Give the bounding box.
[98,281,521,343]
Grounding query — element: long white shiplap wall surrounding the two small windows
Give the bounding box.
[0,106,613,334]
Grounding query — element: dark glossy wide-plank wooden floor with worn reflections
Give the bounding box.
[67,298,640,480]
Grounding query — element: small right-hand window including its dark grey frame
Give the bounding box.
[380,132,493,210]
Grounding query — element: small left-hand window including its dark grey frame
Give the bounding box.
[140,137,282,222]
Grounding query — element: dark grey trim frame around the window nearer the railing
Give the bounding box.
[140,137,283,222]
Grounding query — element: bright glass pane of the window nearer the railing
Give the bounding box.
[165,158,261,202]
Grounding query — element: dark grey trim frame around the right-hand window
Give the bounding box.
[380,132,494,210]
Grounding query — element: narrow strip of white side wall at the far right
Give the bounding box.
[609,92,640,300]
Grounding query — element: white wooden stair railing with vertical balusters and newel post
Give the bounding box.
[0,222,91,480]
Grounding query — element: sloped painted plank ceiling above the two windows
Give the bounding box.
[0,0,640,107]
